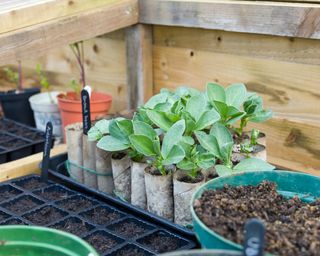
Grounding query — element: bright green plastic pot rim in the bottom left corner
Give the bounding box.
[0,225,98,256]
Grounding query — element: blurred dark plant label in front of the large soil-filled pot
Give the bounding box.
[243,219,265,256]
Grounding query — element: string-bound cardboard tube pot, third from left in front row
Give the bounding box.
[96,147,114,195]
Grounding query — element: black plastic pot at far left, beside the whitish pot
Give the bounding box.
[0,88,40,127]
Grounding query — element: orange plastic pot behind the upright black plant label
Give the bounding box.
[57,92,112,136]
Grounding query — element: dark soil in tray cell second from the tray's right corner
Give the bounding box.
[109,220,148,238]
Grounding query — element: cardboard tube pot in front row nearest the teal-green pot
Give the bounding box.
[173,170,205,226]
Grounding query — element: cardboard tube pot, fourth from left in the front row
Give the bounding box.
[111,153,131,202]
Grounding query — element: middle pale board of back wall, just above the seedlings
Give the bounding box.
[153,46,320,122]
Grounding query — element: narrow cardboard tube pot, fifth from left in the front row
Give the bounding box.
[131,161,148,209]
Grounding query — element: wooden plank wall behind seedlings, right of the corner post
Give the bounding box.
[153,26,320,175]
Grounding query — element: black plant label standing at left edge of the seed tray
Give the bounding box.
[41,122,53,182]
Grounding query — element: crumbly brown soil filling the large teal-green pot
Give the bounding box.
[194,181,320,256]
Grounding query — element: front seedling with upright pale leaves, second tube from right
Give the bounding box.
[129,120,185,175]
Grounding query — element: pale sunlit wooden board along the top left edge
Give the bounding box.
[0,0,121,34]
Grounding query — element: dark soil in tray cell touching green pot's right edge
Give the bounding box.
[85,232,118,254]
